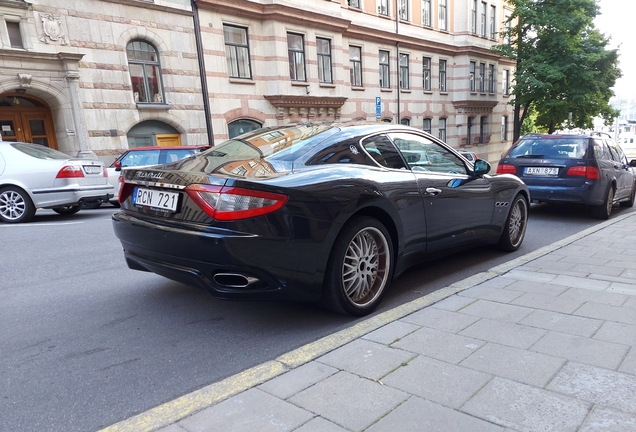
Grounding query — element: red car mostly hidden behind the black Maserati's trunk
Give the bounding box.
[84,146,210,208]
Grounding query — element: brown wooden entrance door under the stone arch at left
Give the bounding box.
[0,93,57,149]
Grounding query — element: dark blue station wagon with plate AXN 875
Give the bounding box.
[497,134,636,219]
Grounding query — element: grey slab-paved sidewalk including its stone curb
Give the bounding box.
[104,213,636,432]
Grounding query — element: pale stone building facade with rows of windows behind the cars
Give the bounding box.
[0,0,514,162]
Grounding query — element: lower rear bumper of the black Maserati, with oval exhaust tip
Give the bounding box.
[112,212,324,301]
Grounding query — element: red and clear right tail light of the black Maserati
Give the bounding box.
[185,184,287,221]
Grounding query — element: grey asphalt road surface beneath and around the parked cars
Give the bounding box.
[0,205,634,431]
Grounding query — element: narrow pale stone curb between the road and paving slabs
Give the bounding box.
[99,213,635,432]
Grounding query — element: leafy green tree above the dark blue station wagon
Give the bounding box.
[492,0,620,140]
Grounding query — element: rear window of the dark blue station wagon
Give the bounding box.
[509,137,589,159]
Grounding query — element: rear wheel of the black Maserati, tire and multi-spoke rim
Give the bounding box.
[321,217,394,316]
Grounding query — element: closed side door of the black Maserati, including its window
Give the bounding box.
[389,132,495,252]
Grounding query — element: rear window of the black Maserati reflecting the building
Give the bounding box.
[199,124,339,175]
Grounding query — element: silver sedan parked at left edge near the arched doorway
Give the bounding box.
[0,141,113,223]
